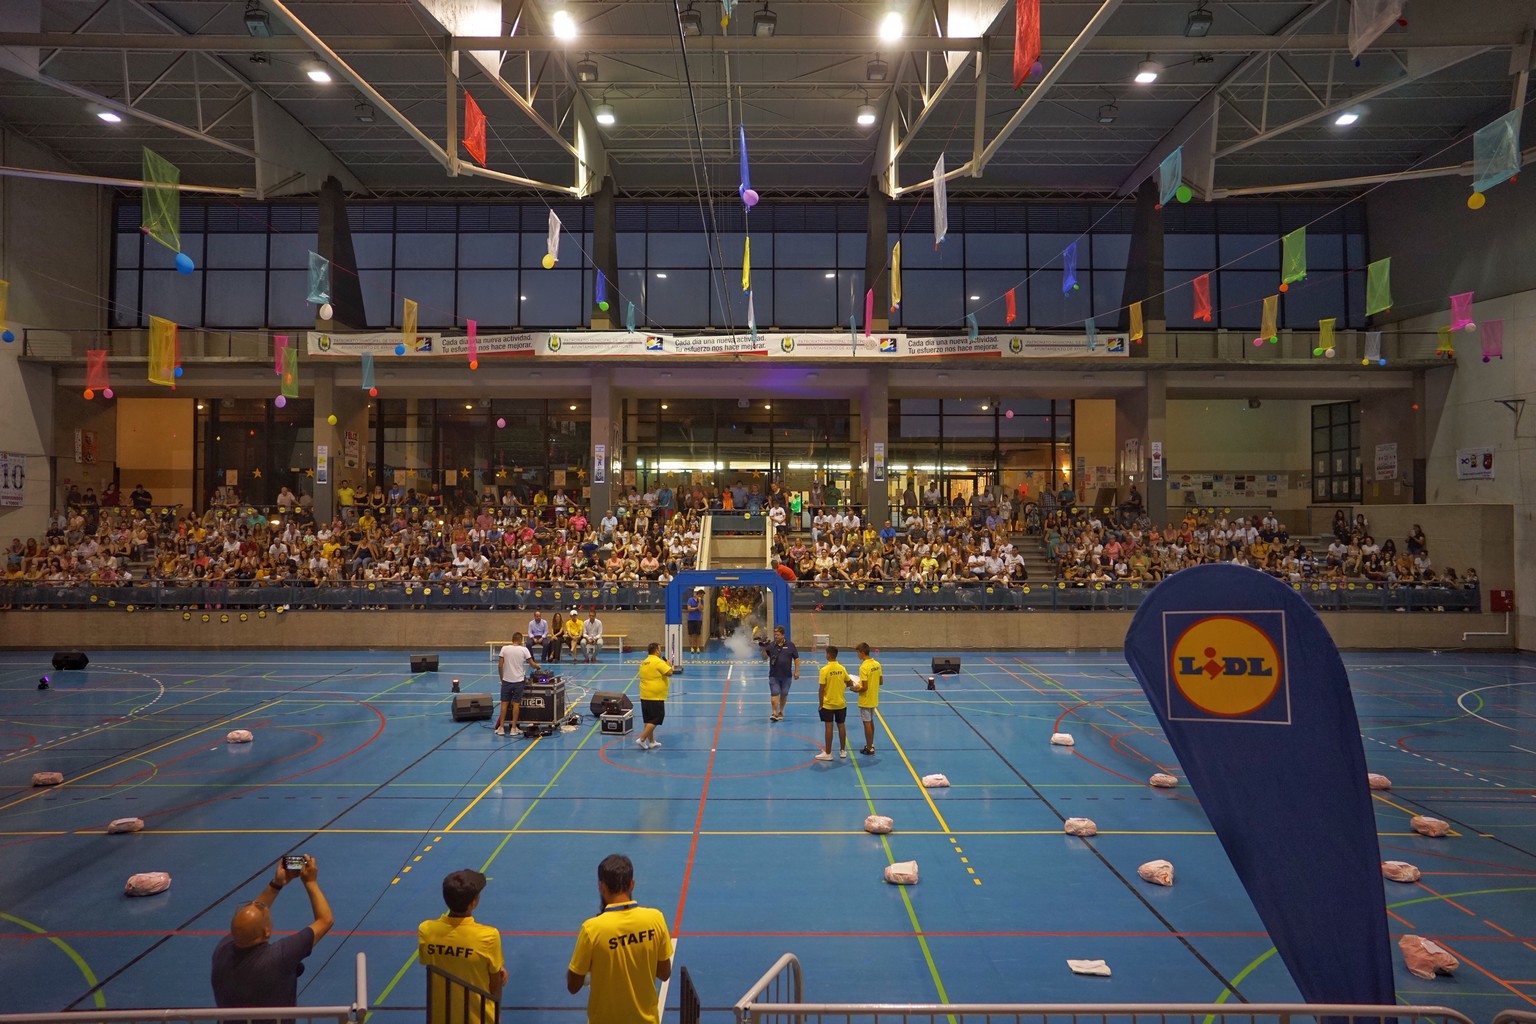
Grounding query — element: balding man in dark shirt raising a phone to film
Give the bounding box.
[212,855,336,1024]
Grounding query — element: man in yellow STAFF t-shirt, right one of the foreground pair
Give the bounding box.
[565,854,673,1024]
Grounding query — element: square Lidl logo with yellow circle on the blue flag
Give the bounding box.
[1163,611,1290,725]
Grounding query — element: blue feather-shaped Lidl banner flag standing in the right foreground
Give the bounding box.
[1126,565,1395,1006]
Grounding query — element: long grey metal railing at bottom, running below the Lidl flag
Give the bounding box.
[734,953,1474,1024]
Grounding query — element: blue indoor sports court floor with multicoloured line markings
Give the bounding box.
[0,639,1536,1022]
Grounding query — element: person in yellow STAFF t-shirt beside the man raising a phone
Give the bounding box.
[416,867,507,1024]
